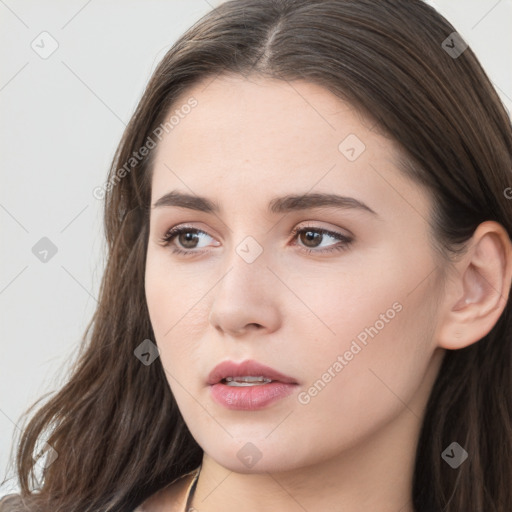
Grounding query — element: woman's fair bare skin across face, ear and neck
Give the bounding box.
[146,75,512,512]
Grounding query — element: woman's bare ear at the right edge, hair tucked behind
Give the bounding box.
[436,221,512,350]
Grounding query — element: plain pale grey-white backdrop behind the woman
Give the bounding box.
[0,0,512,496]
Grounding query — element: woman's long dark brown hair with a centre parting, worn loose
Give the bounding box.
[2,0,512,512]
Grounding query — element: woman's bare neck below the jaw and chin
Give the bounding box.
[191,408,421,512]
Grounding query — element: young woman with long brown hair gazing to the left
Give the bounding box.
[0,0,512,512]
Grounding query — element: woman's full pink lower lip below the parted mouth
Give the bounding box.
[210,381,297,411]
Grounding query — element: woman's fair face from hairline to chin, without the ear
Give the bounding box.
[145,76,448,472]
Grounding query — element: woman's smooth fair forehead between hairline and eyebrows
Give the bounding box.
[152,76,426,220]
